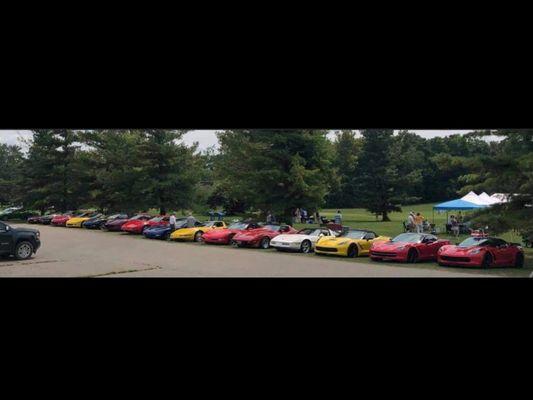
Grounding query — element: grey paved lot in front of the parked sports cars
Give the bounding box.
[0,225,508,277]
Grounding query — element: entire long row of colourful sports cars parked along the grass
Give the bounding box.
[21,212,524,268]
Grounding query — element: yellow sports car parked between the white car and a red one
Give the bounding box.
[315,229,390,258]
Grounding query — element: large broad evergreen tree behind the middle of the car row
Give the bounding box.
[217,129,333,221]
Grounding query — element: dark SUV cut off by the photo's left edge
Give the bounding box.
[0,222,41,260]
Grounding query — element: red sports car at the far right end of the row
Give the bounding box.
[437,237,524,268]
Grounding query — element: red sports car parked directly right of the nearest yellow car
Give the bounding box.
[370,233,450,263]
